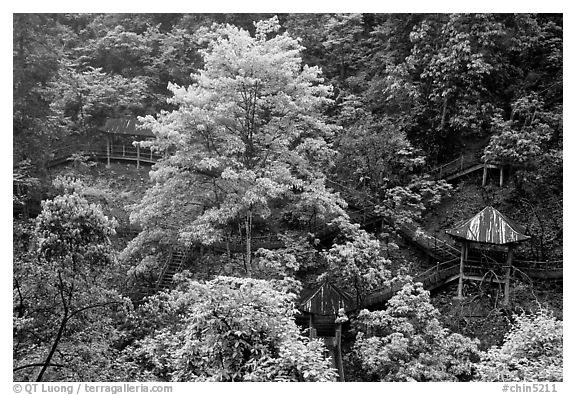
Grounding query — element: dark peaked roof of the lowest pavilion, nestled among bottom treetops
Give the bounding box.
[300,281,354,315]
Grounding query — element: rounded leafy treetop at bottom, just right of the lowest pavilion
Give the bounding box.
[354,283,478,381]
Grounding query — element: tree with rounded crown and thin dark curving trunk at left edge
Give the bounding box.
[14,179,124,381]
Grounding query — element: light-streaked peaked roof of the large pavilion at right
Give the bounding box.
[446,206,530,245]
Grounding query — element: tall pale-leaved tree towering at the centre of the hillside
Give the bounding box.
[132,18,344,275]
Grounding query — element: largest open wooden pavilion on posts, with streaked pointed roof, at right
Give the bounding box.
[446,206,530,306]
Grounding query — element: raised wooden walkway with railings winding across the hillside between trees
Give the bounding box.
[48,145,563,300]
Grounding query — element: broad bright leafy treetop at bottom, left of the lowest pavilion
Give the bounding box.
[126,276,336,381]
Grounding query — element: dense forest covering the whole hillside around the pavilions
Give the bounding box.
[13,13,563,382]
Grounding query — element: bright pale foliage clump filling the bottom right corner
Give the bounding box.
[476,310,563,381]
